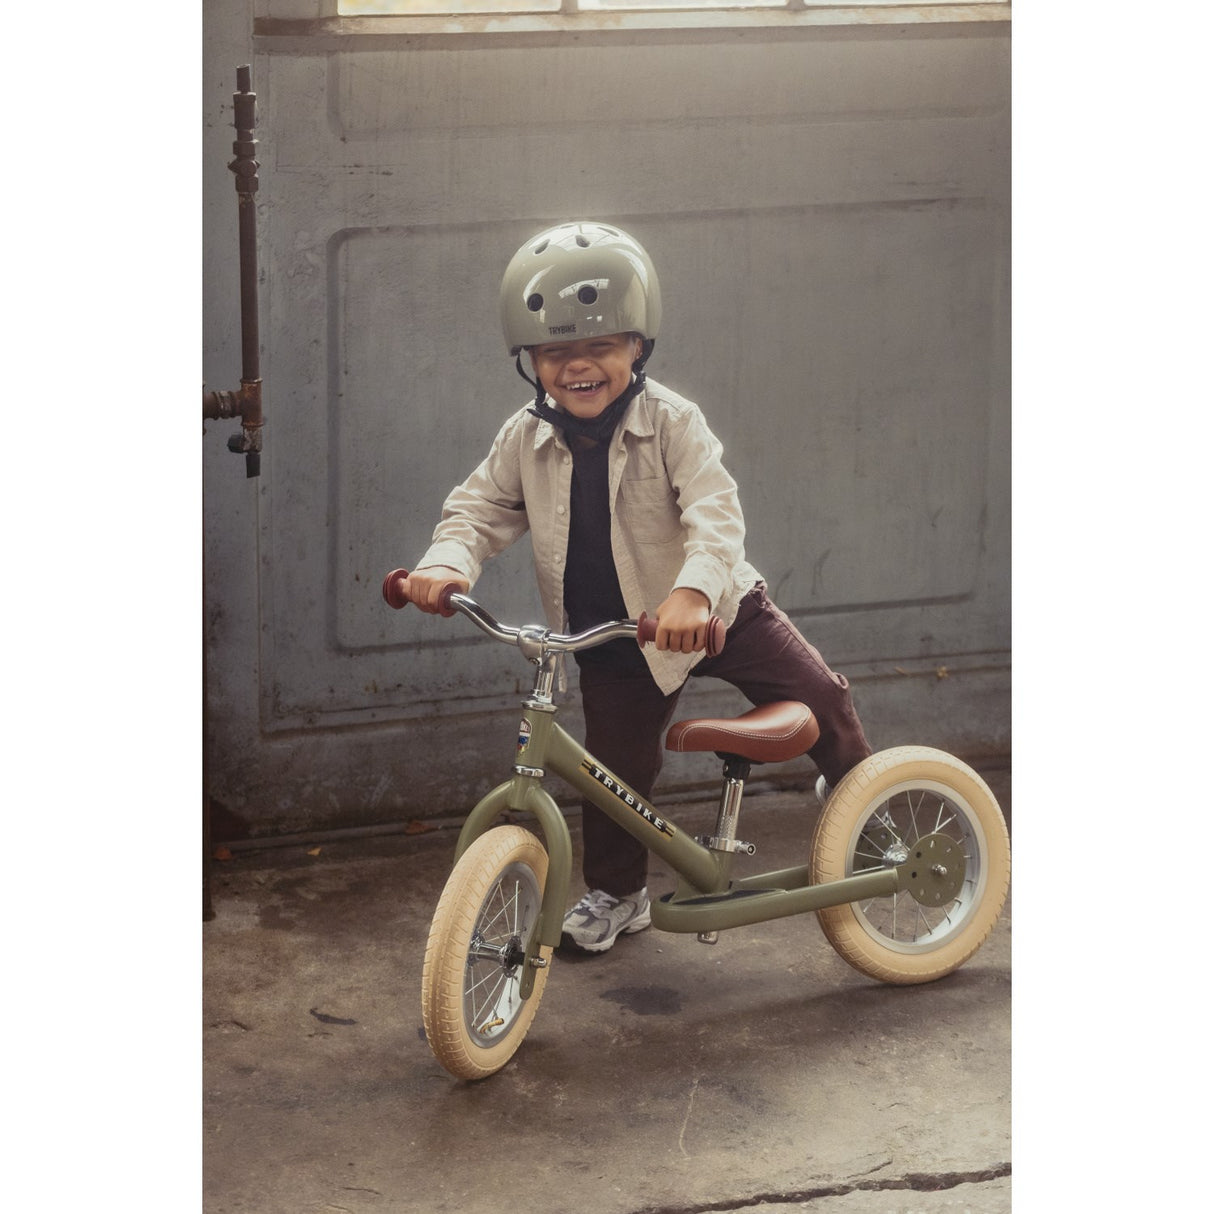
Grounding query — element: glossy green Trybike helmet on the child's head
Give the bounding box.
[500,220,662,354]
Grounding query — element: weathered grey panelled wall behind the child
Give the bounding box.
[203,0,1010,834]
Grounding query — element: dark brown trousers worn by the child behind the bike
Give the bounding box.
[578,583,873,897]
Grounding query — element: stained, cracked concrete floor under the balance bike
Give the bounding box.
[203,766,1011,1214]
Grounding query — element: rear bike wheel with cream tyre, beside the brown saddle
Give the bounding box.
[810,747,1011,983]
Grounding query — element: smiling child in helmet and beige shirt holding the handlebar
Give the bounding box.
[393,222,872,953]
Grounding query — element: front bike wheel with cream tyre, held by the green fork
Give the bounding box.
[421,827,552,1079]
